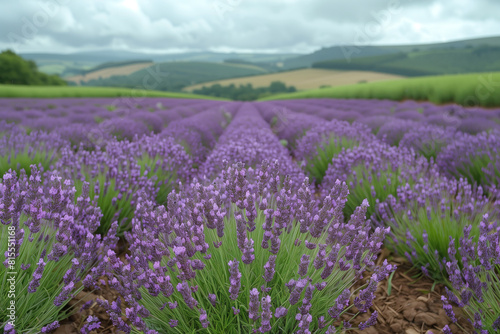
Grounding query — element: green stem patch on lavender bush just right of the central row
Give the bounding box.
[305,136,361,183]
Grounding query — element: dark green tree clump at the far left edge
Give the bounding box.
[0,50,66,86]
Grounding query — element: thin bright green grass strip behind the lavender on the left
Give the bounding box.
[0,85,225,100]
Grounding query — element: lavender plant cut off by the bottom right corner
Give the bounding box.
[441,219,500,334]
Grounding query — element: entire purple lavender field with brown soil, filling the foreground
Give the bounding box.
[0,98,500,334]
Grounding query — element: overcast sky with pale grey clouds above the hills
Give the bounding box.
[0,0,500,53]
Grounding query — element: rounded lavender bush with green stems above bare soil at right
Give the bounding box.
[377,177,494,282]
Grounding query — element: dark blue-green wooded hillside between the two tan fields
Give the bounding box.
[80,62,268,91]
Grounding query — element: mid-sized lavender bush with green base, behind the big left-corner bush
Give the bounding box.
[55,141,158,236]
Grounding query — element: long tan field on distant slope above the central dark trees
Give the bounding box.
[184,69,402,92]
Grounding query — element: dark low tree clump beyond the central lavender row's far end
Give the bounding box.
[193,81,296,101]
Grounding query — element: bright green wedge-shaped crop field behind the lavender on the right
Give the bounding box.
[262,72,500,107]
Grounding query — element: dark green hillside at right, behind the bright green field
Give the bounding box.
[313,46,500,76]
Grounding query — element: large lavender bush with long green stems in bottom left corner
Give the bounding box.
[0,166,117,334]
